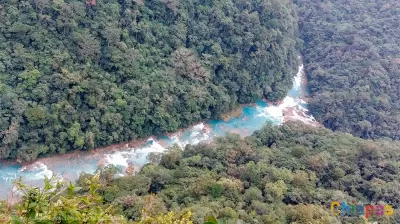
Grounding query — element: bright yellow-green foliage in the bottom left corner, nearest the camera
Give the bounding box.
[0,174,126,224]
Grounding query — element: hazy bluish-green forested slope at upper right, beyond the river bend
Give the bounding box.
[295,0,400,140]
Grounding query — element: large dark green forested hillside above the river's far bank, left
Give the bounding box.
[0,0,297,161]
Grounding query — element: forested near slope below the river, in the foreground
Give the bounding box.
[0,123,400,224]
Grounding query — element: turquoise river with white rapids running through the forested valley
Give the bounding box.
[0,65,319,200]
